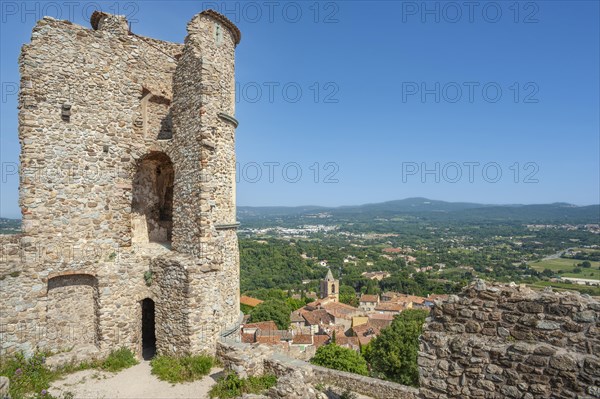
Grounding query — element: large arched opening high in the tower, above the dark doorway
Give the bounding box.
[131,152,175,244]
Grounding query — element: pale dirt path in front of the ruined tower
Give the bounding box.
[48,361,222,399]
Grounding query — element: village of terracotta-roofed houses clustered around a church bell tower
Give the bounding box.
[240,270,448,360]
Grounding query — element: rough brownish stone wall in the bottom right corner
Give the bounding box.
[419,281,600,399]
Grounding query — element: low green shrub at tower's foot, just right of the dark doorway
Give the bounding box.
[150,355,214,383]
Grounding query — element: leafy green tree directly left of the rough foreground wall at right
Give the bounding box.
[365,309,427,386]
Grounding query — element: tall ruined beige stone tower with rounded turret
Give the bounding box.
[0,10,240,360]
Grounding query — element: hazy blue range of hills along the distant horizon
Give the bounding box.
[238,198,600,226]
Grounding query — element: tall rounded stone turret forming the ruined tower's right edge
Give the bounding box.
[172,13,240,350]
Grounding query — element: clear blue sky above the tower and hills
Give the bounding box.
[0,1,600,217]
